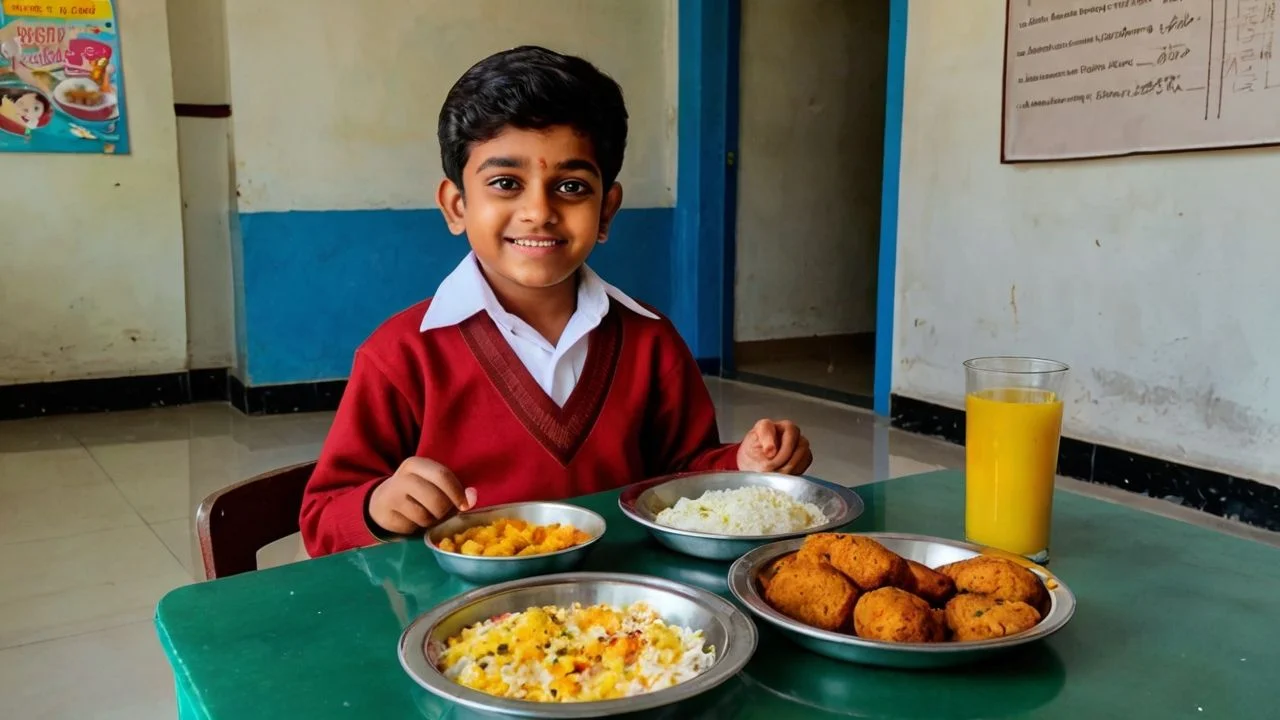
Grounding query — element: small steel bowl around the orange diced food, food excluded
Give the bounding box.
[425,502,604,585]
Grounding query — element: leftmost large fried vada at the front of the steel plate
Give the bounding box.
[764,559,858,632]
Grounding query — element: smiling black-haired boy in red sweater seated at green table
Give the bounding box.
[301,47,813,556]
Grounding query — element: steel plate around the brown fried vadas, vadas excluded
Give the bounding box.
[728,533,1075,669]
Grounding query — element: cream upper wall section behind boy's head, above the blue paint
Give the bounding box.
[225,0,677,211]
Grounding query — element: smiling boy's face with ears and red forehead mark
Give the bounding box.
[436,126,622,291]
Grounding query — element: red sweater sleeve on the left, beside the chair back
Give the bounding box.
[298,351,419,557]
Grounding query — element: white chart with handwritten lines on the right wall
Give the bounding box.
[1002,0,1280,163]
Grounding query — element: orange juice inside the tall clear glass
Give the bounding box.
[965,388,1062,556]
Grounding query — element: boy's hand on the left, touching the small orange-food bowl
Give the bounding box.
[369,457,476,536]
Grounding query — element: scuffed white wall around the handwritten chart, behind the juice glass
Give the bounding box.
[893,0,1280,484]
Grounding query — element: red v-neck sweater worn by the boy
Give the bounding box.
[300,301,737,557]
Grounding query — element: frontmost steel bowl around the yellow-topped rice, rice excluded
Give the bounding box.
[399,573,758,717]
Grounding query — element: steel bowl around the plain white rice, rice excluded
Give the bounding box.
[618,473,863,560]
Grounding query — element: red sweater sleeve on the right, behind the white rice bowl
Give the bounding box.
[645,336,741,475]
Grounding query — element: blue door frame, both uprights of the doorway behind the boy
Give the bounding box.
[672,0,909,415]
